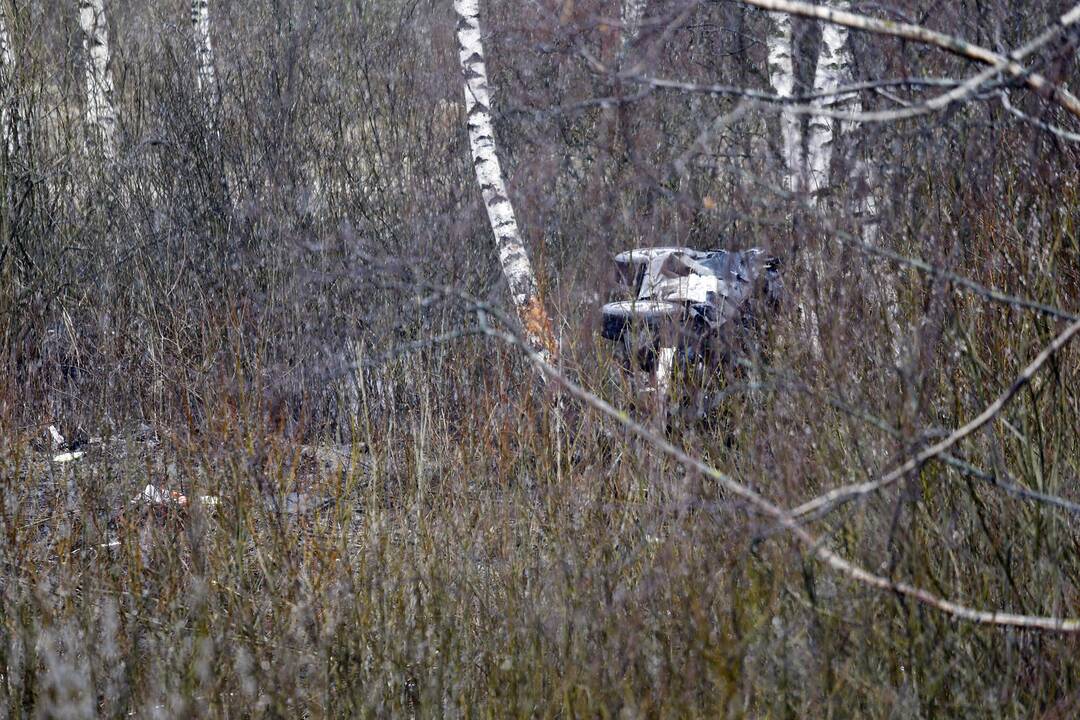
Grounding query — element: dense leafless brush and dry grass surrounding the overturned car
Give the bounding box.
[0,0,1080,718]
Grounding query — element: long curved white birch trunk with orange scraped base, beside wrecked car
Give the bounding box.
[454,0,555,361]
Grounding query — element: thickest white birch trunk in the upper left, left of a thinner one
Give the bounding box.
[79,0,117,161]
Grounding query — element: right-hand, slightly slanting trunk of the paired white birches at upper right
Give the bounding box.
[805,0,851,204]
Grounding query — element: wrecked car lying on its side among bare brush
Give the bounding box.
[603,247,783,405]
